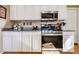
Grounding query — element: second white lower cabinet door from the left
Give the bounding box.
[12,32,22,52]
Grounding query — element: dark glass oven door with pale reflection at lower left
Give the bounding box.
[42,35,63,48]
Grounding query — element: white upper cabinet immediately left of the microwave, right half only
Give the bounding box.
[24,5,41,20]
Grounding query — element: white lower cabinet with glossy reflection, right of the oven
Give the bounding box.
[63,32,74,52]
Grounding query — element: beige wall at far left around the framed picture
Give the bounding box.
[0,5,10,50]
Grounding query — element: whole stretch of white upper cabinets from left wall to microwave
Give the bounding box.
[10,5,41,20]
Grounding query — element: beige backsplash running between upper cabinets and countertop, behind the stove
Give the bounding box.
[4,20,63,29]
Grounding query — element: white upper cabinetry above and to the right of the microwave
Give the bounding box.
[40,5,67,20]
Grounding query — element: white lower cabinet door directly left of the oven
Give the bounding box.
[32,31,41,52]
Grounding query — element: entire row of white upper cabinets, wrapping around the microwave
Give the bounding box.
[10,5,66,20]
